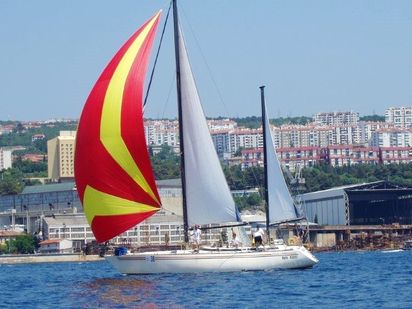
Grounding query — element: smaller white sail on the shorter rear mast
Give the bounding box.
[262,103,297,224]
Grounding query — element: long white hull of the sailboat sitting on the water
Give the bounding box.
[106,246,318,275]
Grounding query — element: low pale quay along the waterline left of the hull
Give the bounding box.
[0,253,104,265]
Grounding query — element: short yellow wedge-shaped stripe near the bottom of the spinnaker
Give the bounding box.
[83,186,159,224]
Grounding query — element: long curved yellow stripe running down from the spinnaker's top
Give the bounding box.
[100,12,160,204]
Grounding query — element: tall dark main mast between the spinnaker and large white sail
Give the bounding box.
[172,0,189,243]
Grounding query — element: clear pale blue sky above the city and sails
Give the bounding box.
[0,0,412,121]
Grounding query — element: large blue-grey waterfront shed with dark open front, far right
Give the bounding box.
[301,181,412,225]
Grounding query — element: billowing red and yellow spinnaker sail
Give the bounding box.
[75,12,160,242]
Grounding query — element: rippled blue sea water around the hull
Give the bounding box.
[0,251,412,309]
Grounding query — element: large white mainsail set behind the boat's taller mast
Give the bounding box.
[179,27,237,225]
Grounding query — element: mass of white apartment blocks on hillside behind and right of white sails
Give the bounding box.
[141,107,412,171]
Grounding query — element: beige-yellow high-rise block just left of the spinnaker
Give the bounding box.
[47,131,76,181]
